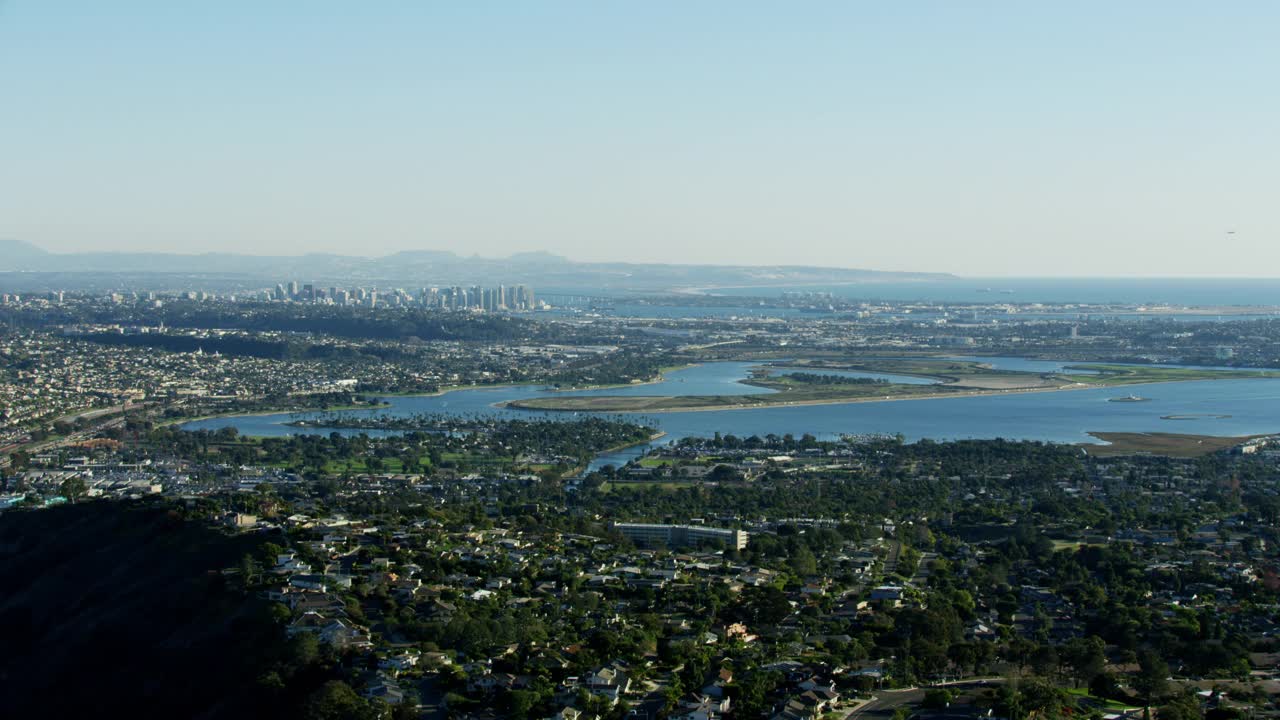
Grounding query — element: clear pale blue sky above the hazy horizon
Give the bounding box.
[0,0,1280,277]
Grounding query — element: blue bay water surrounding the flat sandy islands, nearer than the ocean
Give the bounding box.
[183,357,1280,466]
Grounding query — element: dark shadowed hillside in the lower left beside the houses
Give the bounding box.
[0,502,317,717]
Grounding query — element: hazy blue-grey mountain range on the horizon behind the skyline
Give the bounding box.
[0,240,951,292]
